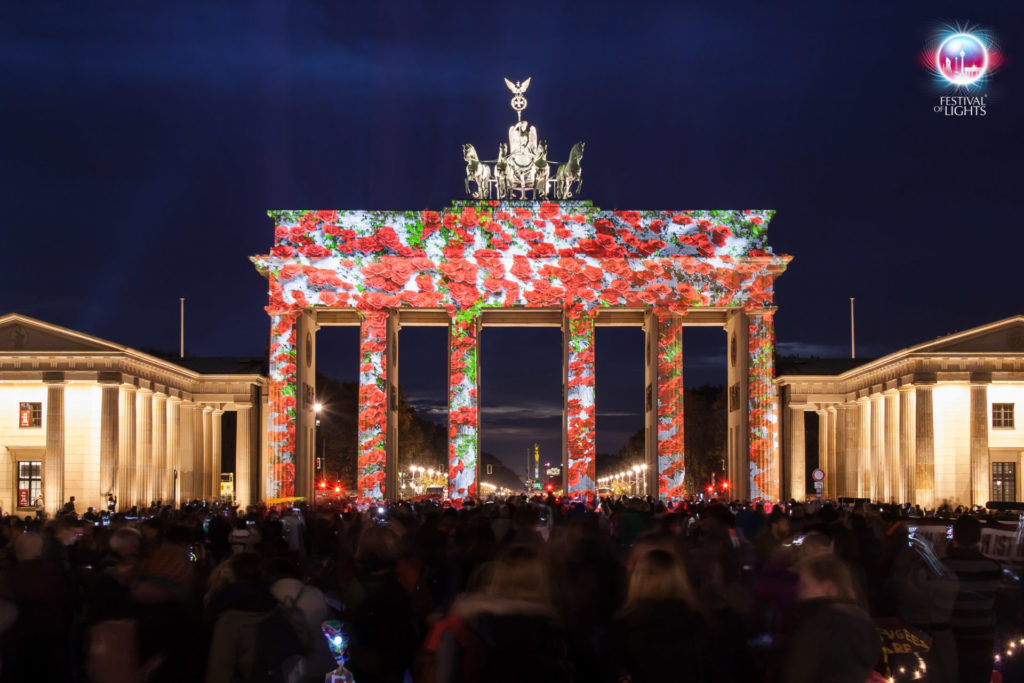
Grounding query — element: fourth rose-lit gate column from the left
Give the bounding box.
[562,311,597,496]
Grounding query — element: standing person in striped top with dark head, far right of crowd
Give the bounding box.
[943,515,1002,683]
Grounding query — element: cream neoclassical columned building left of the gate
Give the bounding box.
[0,313,266,514]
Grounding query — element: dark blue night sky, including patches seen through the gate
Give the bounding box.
[0,0,1024,481]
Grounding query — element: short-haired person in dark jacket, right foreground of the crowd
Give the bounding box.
[780,554,882,683]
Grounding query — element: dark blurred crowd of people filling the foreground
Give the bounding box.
[0,496,1024,683]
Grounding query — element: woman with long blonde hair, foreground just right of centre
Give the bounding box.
[605,549,720,683]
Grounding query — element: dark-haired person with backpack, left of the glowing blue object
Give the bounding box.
[206,553,305,683]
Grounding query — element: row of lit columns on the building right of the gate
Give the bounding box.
[785,373,992,507]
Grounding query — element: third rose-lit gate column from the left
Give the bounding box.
[449,311,480,502]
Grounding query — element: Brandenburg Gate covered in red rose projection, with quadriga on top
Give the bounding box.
[252,79,791,503]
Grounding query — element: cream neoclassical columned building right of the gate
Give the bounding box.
[775,315,1024,507]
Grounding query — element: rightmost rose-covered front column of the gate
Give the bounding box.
[746,308,781,501]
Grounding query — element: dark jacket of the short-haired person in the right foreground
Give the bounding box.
[781,598,882,683]
